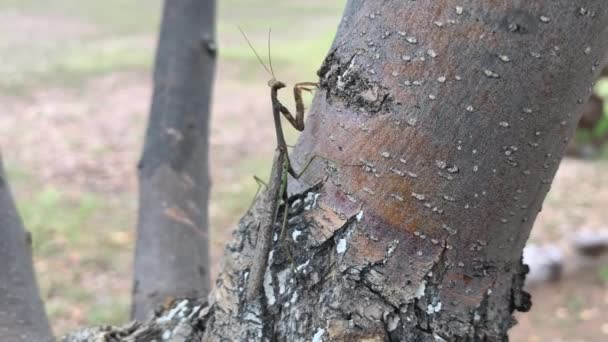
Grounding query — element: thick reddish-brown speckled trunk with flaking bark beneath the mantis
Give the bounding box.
[64,0,608,342]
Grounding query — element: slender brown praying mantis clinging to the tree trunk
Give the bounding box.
[239,28,318,301]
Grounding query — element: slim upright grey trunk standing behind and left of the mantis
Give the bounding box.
[132,0,216,319]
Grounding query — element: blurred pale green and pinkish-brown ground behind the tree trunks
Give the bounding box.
[0,0,608,341]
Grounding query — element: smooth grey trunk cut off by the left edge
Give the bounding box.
[0,158,53,342]
